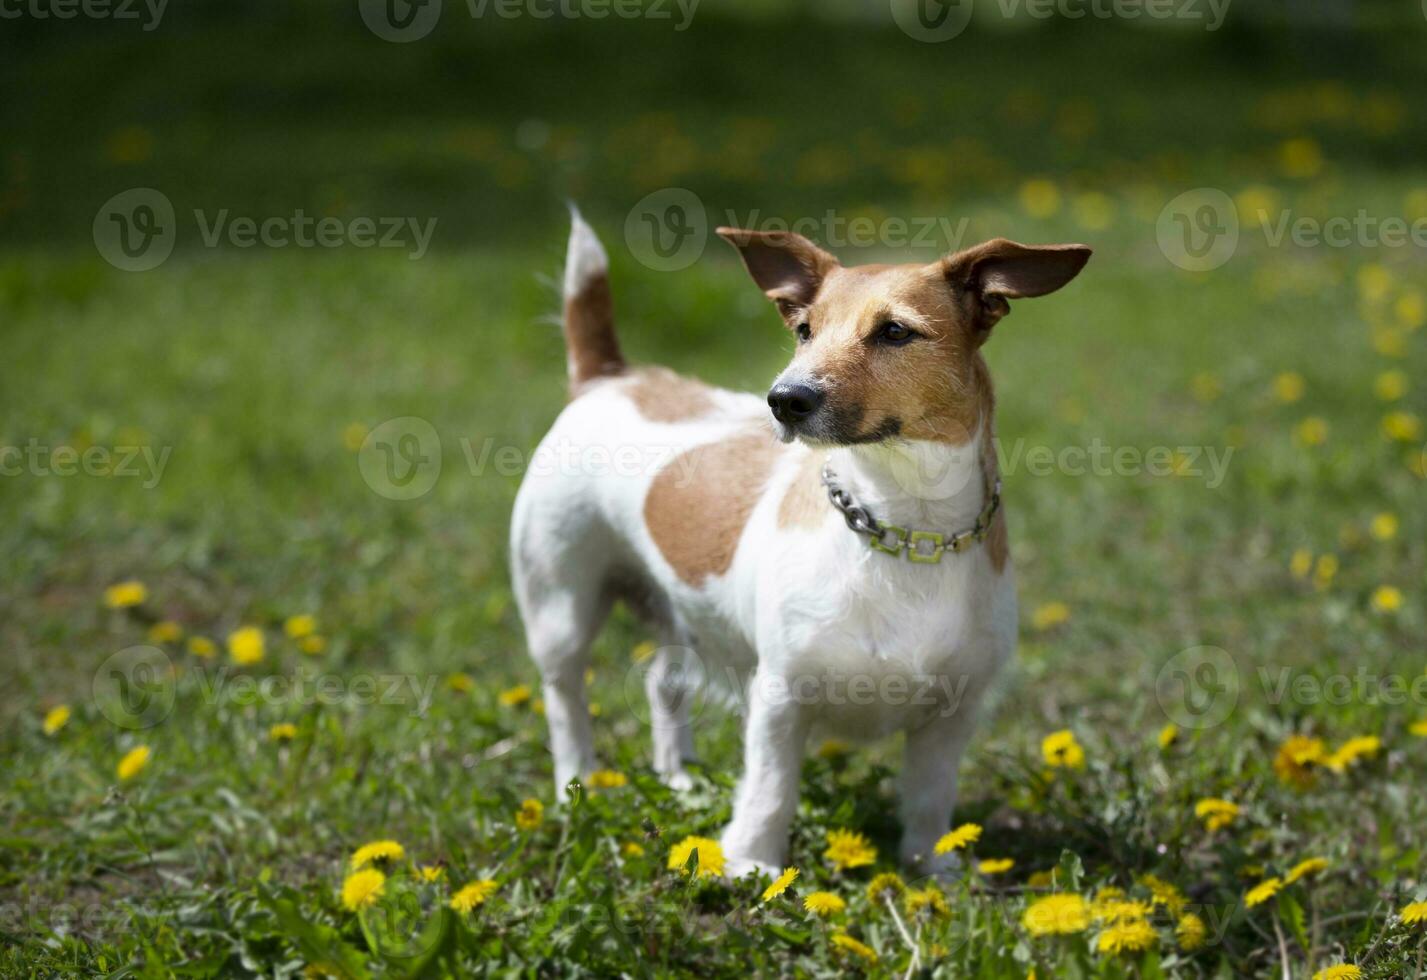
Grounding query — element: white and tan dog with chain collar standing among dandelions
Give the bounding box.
[511,211,1090,877]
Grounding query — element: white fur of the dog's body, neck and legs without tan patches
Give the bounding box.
[511,218,1016,874]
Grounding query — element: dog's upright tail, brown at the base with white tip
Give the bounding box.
[565,205,625,395]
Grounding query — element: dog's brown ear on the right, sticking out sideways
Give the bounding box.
[942,238,1090,331]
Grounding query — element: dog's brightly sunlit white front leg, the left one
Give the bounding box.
[721,675,808,877]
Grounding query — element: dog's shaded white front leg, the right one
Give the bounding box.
[900,703,976,874]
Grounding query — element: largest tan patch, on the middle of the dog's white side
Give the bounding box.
[644,431,781,585]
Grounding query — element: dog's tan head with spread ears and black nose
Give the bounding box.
[718,228,1090,445]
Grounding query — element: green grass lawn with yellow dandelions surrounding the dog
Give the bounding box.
[0,6,1427,977]
